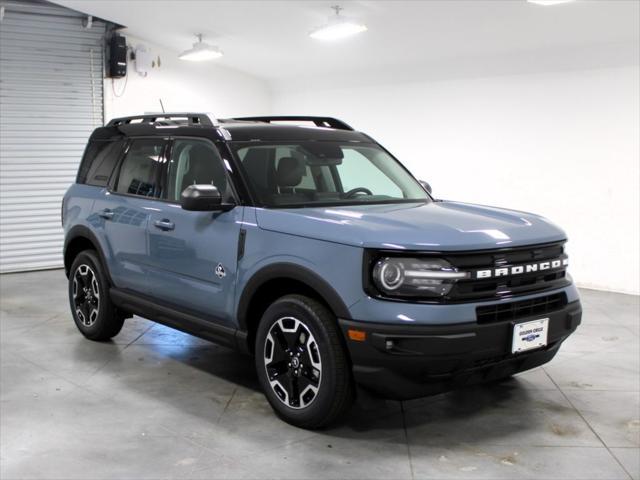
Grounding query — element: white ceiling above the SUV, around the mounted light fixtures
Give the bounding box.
[55,0,640,86]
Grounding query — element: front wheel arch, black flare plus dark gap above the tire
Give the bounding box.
[237,263,351,352]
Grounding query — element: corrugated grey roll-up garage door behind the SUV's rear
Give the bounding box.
[0,0,105,272]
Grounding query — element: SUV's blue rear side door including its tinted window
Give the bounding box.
[94,137,168,293]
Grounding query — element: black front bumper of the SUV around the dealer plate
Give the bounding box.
[340,301,582,400]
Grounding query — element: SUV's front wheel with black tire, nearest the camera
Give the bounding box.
[255,295,355,429]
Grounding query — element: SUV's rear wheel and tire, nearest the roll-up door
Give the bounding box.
[69,250,125,341]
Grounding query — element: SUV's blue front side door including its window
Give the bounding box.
[147,138,243,324]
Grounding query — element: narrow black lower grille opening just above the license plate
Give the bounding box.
[476,293,567,324]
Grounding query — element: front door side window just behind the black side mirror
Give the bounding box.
[165,139,231,201]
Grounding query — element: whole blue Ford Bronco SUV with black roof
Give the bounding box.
[62,113,582,428]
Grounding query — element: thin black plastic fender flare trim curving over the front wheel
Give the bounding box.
[237,262,351,332]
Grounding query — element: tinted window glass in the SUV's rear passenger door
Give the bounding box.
[116,138,165,197]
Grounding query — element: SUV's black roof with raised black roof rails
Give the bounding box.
[92,113,373,143]
